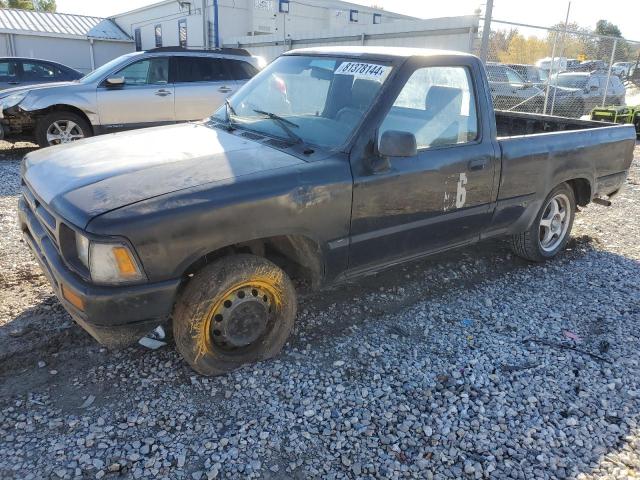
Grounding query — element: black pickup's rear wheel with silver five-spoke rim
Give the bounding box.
[511,183,576,262]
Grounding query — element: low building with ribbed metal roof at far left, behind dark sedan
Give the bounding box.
[0,8,134,72]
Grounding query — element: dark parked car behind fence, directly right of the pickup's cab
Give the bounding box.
[486,63,544,113]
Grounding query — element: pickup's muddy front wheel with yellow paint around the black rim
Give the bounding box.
[173,254,297,376]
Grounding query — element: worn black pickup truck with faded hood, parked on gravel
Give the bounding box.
[19,47,636,375]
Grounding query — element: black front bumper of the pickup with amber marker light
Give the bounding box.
[18,198,180,348]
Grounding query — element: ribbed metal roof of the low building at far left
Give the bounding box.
[0,8,131,42]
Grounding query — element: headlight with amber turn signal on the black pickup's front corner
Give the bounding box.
[76,233,146,283]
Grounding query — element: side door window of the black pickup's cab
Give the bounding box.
[379,67,478,149]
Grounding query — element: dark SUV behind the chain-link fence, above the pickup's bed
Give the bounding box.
[547,72,626,118]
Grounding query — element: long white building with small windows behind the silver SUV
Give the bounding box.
[112,0,412,50]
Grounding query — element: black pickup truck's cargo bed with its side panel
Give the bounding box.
[488,111,636,239]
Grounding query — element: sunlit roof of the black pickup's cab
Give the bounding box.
[284,46,473,59]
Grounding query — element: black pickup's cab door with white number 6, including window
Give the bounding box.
[349,61,496,269]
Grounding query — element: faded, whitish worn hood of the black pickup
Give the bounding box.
[23,123,304,228]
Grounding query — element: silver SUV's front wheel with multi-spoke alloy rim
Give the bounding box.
[35,110,93,148]
